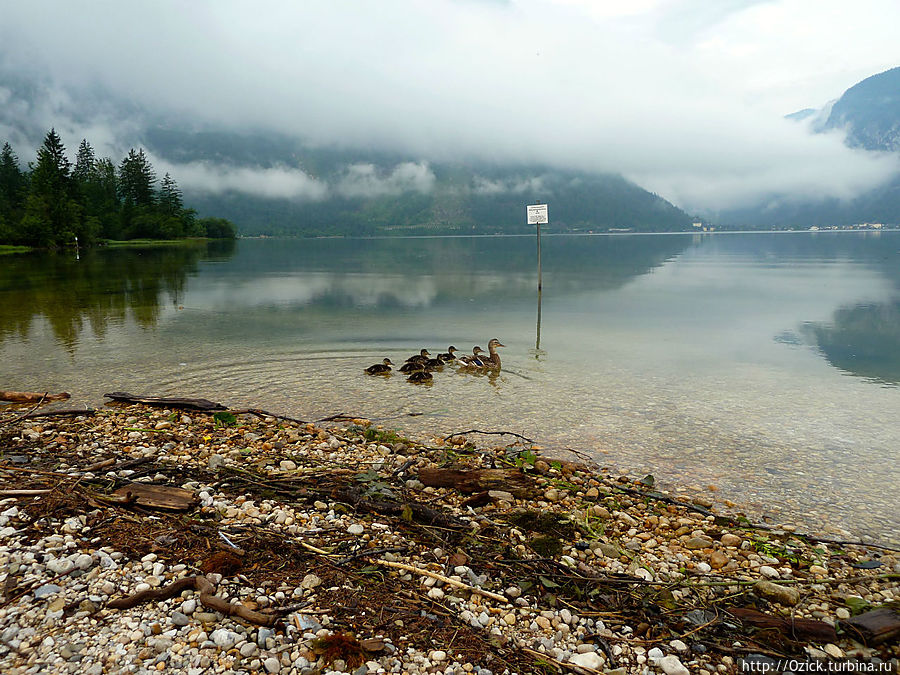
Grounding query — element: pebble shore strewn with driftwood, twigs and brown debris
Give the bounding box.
[0,405,900,675]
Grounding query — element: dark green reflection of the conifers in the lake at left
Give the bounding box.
[0,242,234,351]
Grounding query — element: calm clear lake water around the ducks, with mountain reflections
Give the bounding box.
[0,232,900,544]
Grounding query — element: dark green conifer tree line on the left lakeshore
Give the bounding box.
[0,129,236,248]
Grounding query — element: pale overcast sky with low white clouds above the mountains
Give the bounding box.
[0,0,900,211]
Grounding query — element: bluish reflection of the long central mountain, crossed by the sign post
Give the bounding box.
[223,236,691,308]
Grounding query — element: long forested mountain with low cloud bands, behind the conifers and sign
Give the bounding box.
[0,64,692,235]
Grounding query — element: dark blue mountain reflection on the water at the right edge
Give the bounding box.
[804,299,900,384]
